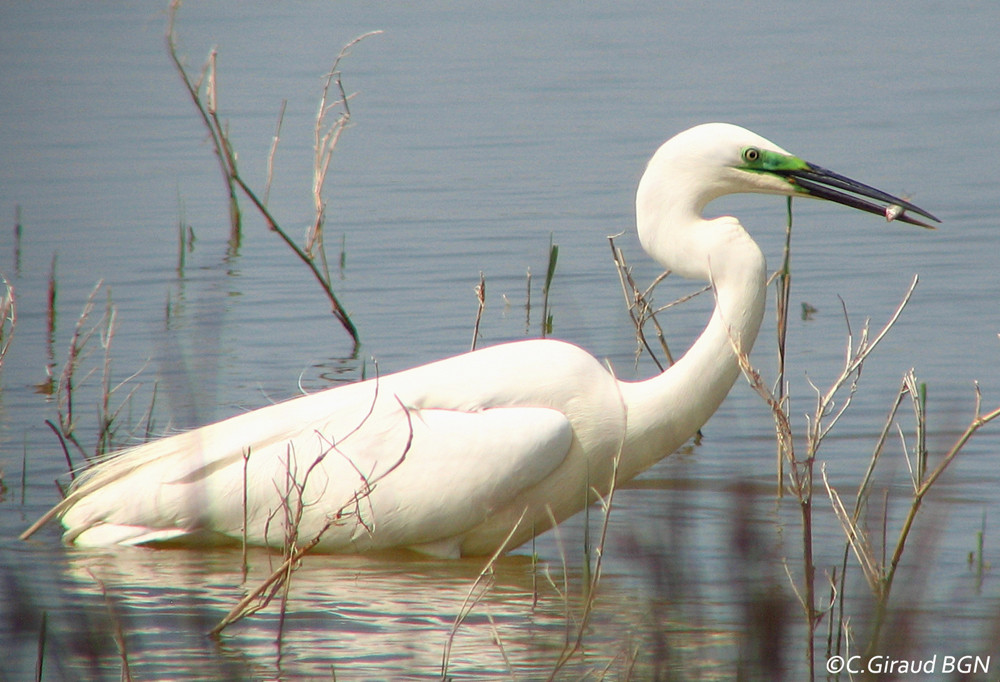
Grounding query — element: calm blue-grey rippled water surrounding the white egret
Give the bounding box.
[0,2,1000,679]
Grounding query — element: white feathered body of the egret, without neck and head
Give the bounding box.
[62,340,625,556]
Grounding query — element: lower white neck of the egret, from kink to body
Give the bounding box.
[619,218,767,481]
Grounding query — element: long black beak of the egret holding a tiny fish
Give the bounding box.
[779,163,941,230]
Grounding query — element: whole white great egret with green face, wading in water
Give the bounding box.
[22,123,937,557]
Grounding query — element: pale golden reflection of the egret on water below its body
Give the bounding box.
[47,548,733,679]
